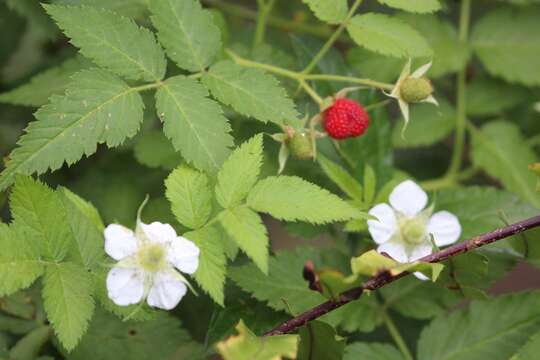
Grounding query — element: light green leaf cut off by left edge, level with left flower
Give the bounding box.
[0,223,43,297]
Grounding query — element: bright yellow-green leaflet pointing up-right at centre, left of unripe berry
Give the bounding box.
[216,135,263,208]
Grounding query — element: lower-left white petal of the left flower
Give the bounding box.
[107,267,144,306]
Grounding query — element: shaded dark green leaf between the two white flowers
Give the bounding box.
[228,248,326,314]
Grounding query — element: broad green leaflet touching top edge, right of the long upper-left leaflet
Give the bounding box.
[149,0,221,71]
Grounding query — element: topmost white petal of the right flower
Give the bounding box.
[389,180,428,216]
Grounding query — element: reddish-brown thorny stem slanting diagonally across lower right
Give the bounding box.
[264,215,540,336]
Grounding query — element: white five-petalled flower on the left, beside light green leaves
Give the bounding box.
[105,220,199,310]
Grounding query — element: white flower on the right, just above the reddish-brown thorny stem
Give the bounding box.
[367,180,461,277]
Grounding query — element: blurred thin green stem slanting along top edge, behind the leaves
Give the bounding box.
[203,0,332,39]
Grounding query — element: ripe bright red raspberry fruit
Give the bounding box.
[323,98,369,140]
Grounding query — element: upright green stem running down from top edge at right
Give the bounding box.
[448,0,471,176]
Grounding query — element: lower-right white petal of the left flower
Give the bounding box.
[147,270,187,310]
